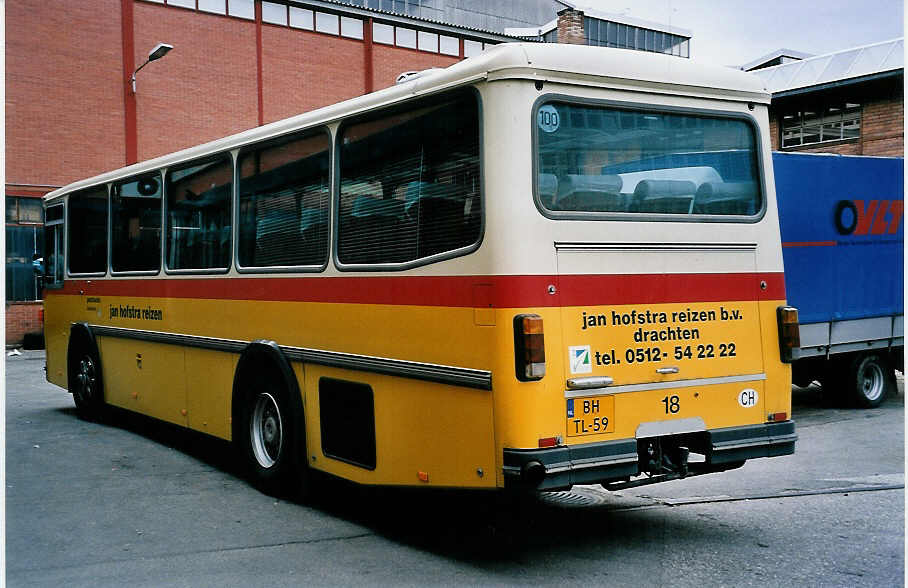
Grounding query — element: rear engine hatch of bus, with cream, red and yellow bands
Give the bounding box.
[556,242,766,444]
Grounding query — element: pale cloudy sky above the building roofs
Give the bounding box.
[576,0,904,65]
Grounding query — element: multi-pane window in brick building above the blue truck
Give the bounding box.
[781,102,861,148]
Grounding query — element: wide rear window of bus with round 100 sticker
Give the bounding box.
[535,102,763,220]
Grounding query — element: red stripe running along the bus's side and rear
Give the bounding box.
[62,272,785,308]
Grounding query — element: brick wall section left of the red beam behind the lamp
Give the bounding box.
[6,0,124,186]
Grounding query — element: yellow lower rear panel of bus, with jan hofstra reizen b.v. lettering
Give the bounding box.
[492,300,791,449]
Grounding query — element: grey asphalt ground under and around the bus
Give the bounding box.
[5,351,905,587]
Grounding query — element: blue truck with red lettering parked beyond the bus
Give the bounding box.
[773,152,905,407]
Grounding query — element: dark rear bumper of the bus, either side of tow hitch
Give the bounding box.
[503,421,798,490]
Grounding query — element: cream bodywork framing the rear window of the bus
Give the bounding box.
[483,76,782,274]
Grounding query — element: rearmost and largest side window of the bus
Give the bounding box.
[337,92,482,265]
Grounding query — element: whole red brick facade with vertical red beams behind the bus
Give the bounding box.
[6,0,476,189]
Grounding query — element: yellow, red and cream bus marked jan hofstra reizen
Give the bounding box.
[45,44,797,490]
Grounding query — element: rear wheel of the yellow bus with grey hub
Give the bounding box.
[237,372,306,495]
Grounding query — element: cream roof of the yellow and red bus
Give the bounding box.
[44,43,770,200]
